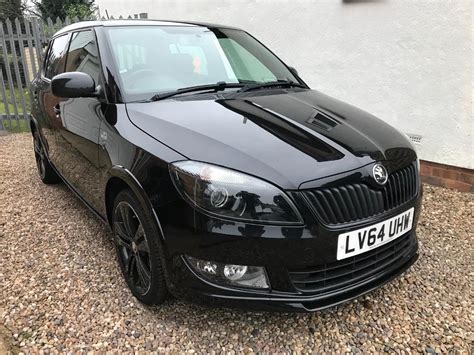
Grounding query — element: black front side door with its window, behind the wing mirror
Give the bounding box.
[57,29,102,210]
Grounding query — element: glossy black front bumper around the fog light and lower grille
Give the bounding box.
[162,192,421,312]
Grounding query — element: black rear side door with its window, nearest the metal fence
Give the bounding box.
[32,34,69,166]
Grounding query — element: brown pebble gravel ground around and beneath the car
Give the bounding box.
[0,134,474,352]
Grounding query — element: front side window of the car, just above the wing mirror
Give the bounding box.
[66,31,100,84]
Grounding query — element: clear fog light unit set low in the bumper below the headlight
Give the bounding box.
[186,256,270,289]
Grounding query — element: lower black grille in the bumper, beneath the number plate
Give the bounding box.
[290,233,410,294]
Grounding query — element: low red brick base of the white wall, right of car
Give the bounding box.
[420,160,474,192]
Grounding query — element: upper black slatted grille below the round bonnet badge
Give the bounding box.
[301,164,418,224]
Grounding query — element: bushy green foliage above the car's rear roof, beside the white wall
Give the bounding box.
[33,0,96,20]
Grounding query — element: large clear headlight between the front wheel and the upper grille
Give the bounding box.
[170,160,303,225]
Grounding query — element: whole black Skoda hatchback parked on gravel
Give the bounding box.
[31,20,422,311]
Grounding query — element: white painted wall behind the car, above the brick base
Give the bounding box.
[96,0,474,169]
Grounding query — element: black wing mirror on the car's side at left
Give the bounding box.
[51,72,98,98]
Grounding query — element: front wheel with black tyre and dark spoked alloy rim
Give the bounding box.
[112,189,168,305]
